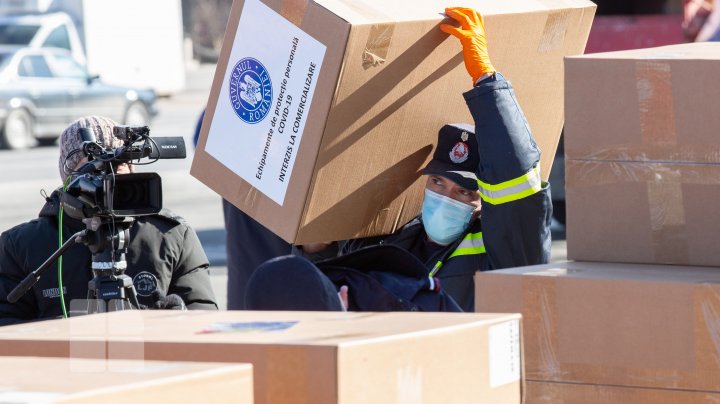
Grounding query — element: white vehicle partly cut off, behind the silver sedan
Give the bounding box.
[0,12,86,65]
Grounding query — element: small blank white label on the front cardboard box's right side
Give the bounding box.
[488,320,520,388]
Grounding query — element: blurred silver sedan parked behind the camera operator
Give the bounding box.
[0,46,157,149]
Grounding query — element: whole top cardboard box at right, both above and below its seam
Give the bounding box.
[565,43,720,266]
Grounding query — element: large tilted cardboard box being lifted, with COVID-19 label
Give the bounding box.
[191,0,595,243]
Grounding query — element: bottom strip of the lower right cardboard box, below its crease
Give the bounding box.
[525,382,720,404]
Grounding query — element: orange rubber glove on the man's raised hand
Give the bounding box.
[440,7,495,85]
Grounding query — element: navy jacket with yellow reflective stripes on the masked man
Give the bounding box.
[341,73,552,311]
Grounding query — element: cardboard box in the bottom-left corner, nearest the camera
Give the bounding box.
[0,356,253,404]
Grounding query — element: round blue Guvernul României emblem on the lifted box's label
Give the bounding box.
[230,58,272,123]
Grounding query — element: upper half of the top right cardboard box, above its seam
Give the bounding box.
[565,42,720,163]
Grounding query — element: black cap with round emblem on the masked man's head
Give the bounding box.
[422,123,480,191]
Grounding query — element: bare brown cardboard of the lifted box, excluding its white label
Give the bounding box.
[191,0,595,243]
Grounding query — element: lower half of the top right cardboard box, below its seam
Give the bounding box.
[565,160,720,266]
